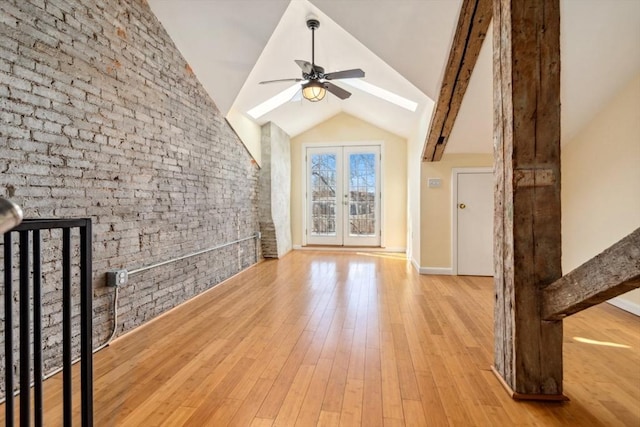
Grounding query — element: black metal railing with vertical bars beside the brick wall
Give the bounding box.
[4,219,93,427]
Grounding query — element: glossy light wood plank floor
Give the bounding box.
[2,251,640,427]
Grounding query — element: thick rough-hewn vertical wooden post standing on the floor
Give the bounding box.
[493,0,564,400]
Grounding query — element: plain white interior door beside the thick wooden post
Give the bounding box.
[454,170,493,276]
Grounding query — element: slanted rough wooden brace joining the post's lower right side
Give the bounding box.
[542,228,640,320]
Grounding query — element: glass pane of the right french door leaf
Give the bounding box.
[347,153,377,237]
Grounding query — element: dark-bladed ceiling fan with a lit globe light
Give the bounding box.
[260,19,364,102]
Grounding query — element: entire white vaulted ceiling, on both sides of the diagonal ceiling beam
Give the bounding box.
[148,0,640,153]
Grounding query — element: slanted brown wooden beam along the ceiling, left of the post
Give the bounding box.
[422,0,492,162]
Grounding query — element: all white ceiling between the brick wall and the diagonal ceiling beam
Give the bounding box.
[149,0,461,136]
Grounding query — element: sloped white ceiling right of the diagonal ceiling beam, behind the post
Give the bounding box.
[446,0,640,153]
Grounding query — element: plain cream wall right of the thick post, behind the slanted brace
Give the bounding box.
[562,74,640,315]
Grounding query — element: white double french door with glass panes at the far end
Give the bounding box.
[305,145,380,246]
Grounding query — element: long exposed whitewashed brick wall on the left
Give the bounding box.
[0,0,258,394]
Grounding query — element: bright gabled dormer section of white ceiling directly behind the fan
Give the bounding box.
[233,0,438,136]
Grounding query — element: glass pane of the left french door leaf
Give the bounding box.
[310,153,337,236]
